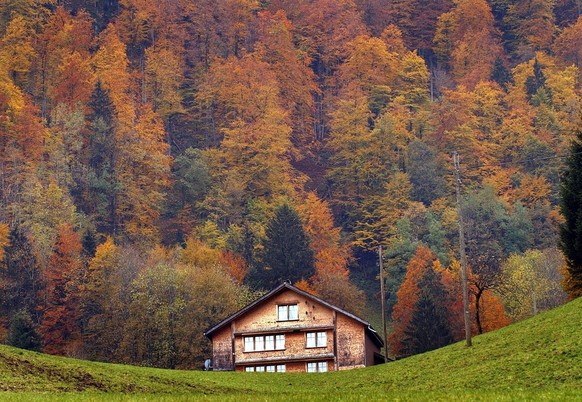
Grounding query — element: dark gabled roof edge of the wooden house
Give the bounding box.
[204,282,384,348]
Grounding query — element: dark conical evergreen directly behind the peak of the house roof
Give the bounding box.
[254,204,315,288]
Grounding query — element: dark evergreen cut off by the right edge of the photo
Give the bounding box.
[560,131,582,297]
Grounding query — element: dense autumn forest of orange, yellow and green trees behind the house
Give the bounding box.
[0,0,582,368]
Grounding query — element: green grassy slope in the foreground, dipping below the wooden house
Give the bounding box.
[0,298,582,401]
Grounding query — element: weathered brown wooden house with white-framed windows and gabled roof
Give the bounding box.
[205,283,384,372]
